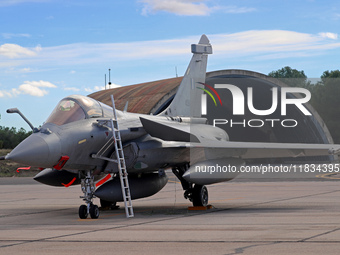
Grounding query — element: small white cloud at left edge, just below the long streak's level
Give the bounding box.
[0,43,41,58]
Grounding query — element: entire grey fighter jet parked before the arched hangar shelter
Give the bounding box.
[2,35,340,219]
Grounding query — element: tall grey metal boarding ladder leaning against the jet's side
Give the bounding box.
[92,95,134,218]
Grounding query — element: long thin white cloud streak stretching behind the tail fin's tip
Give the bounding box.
[0,30,340,73]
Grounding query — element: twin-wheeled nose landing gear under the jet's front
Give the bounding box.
[79,171,99,219]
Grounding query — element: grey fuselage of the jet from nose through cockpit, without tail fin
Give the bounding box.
[7,96,227,176]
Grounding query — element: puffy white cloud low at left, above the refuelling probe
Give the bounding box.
[0,81,57,97]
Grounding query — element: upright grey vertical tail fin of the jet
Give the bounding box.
[160,35,212,117]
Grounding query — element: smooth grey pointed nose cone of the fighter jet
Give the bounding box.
[6,134,60,167]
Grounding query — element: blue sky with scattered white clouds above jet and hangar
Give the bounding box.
[0,0,340,130]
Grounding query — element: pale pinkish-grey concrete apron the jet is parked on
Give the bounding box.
[0,170,340,255]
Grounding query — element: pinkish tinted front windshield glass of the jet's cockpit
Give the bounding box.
[46,99,86,126]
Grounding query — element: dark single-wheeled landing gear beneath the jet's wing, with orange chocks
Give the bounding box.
[172,164,209,206]
